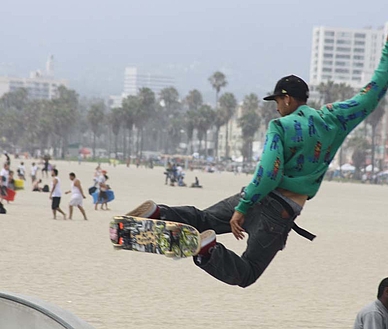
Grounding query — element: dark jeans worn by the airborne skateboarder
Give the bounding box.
[159,191,302,287]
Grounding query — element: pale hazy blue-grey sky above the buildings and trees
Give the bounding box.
[0,0,388,100]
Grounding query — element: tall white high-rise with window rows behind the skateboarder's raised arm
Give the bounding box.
[310,23,388,90]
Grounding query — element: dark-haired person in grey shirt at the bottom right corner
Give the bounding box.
[353,278,388,329]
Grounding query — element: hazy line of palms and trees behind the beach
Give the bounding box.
[0,71,384,167]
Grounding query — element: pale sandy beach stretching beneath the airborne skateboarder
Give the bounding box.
[0,159,388,329]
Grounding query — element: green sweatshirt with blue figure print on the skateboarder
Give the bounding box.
[235,40,388,214]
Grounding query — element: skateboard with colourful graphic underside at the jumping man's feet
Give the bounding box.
[109,216,201,258]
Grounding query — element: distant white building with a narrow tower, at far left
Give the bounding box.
[0,55,68,99]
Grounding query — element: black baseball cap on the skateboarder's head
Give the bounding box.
[263,75,309,101]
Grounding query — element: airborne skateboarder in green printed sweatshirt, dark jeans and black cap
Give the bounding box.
[129,36,388,287]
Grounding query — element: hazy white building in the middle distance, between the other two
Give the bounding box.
[124,67,175,96]
